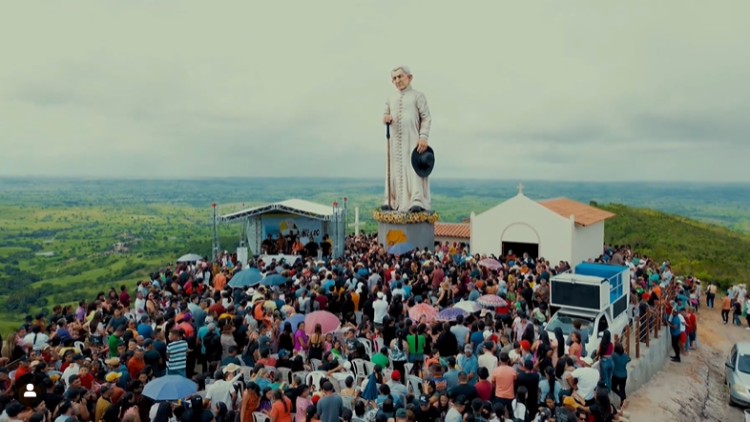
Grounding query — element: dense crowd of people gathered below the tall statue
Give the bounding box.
[0,236,684,422]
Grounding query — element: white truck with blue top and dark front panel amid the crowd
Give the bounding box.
[545,264,630,356]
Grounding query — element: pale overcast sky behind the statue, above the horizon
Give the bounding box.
[0,0,750,181]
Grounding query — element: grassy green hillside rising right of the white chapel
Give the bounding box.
[604,204,750,287]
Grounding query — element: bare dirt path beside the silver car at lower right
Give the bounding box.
[627,301,750,422]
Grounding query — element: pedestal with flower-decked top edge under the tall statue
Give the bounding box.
[373,211,439,251]
